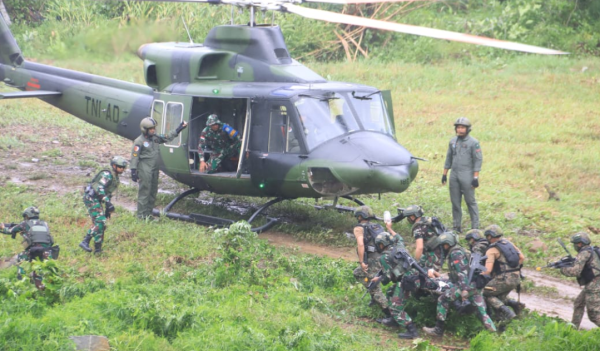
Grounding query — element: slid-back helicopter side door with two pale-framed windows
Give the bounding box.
[152,93,192,173]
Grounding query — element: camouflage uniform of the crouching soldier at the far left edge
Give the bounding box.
[1,219,54,281]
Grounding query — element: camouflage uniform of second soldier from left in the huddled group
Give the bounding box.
[379,243,412,327]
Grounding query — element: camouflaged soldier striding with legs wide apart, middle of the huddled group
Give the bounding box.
[423,232,496,336]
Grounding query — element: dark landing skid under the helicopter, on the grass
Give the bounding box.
[152,189,285,233]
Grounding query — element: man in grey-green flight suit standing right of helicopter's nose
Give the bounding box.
[442,117,483,233]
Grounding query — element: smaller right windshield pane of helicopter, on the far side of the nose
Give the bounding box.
[351,92,393,135]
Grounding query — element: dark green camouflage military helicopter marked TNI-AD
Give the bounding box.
[0,0,565,231]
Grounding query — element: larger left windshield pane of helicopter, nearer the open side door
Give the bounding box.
[294,94,359,149]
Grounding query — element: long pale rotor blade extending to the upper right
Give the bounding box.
[281,4,568,55]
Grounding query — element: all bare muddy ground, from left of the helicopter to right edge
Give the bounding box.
[0,126,595,329]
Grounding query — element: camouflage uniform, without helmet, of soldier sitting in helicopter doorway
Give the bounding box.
[198,123,242,173]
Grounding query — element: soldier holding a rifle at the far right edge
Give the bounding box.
[560,232,600,329]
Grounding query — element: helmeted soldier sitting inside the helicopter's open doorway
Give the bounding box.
[198,114,241,173]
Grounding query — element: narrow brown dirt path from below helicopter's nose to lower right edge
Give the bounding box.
[259,231,596,329]
